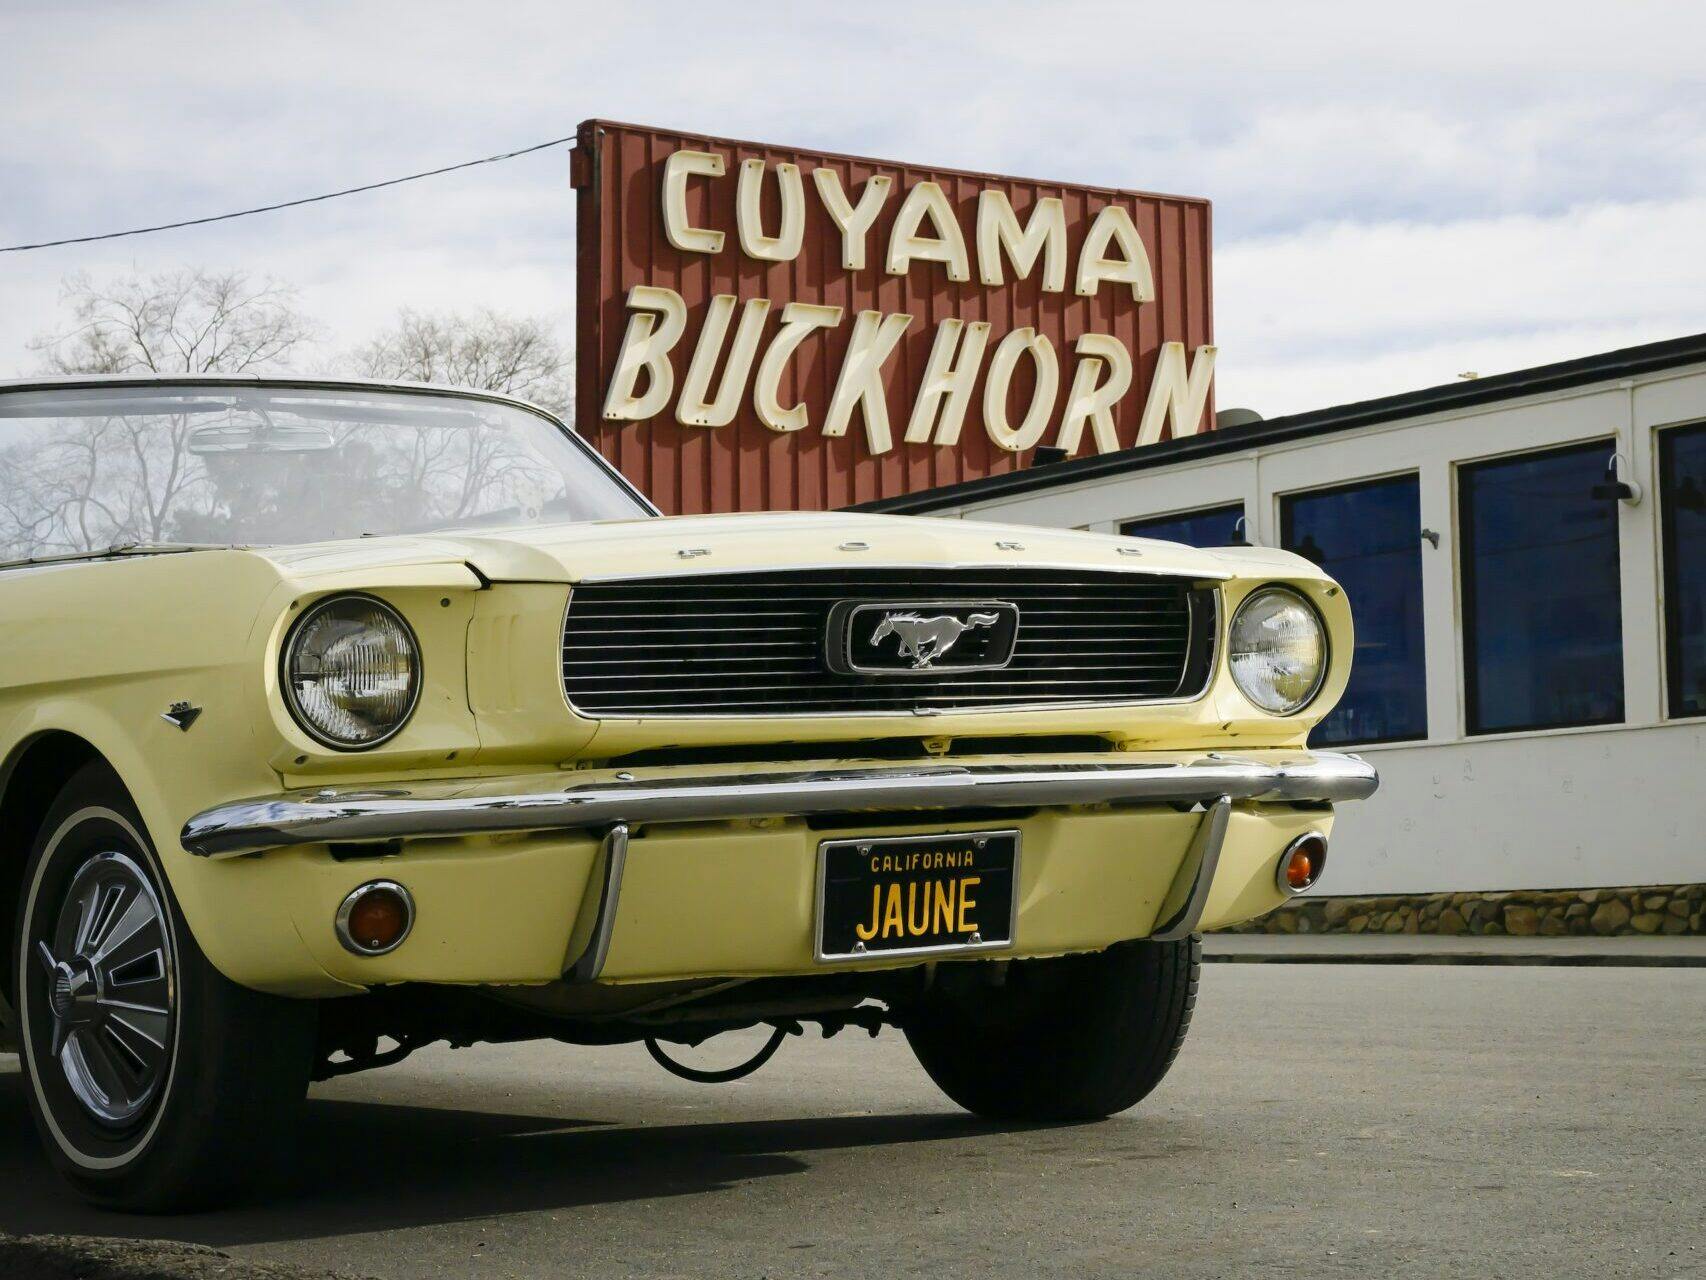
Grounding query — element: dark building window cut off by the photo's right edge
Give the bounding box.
[1658,423,1706,715]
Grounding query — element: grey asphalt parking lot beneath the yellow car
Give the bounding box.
[0,964,1706,1280]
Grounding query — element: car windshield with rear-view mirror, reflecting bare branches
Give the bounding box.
[0,386,650,561]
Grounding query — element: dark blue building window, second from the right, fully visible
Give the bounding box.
[1459,440,1622,734]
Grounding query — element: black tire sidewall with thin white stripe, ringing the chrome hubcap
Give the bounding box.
[12,802,185,1186]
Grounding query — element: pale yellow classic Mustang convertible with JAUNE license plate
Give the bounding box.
[0,377,1375,1208]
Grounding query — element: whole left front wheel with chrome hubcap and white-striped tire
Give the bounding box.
[12,765,316,1212]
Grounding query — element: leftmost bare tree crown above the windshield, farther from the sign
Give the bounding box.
[31,266,316,374]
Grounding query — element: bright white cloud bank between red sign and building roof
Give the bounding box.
[1215,196,1706,415]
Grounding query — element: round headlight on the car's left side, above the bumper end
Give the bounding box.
[283,596,421,751]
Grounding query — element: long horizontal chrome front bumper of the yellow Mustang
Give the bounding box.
[181,751,1378,858]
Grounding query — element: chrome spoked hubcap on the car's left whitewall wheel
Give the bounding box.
[36,852,177,1126]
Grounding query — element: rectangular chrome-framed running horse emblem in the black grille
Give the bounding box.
[824,601,1018,676]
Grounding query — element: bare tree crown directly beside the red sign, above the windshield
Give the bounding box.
[353,309,575,415]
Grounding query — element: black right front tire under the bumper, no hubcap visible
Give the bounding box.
[906,937,1203,1120]
